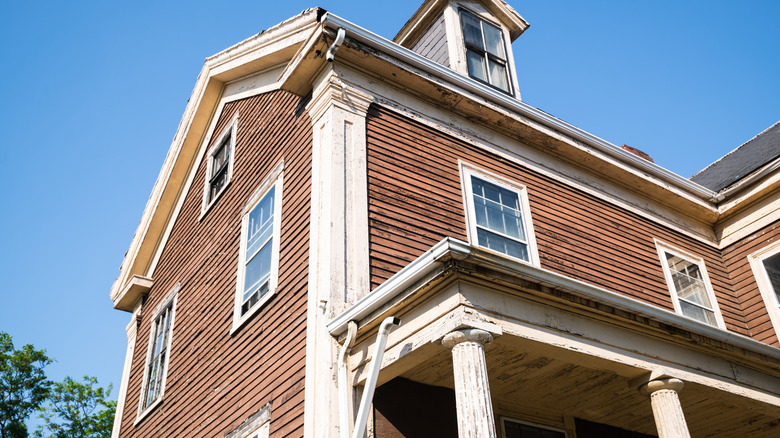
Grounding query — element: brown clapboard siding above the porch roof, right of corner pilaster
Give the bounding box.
[366,105,747,334]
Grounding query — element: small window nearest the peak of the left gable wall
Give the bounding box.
[202,114,238,213]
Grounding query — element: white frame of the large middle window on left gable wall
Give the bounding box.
[230,162,284,334]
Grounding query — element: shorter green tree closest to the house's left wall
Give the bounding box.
[34,376,116,438]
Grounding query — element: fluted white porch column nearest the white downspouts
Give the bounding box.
[441,329,496,438]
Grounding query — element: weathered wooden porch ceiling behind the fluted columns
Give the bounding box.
[401,335,780,437]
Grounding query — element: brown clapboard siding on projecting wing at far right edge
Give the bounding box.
[723,221,780,346]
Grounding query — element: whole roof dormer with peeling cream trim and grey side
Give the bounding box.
[393,0,528,100]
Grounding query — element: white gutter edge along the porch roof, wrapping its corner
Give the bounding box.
[328,237,780,361]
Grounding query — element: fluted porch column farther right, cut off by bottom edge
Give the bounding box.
[639,377,691,438]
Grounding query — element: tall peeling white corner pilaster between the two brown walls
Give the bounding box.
[304,63,373,438]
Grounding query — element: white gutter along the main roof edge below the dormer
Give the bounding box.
[321,13,716,205]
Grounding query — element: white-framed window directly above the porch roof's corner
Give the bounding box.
[463,167,537,264]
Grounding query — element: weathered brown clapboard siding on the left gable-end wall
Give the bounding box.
[121,91,312,437]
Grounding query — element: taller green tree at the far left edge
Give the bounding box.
[0,332,51,438]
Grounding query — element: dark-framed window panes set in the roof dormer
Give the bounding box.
[460,9,511,94]
